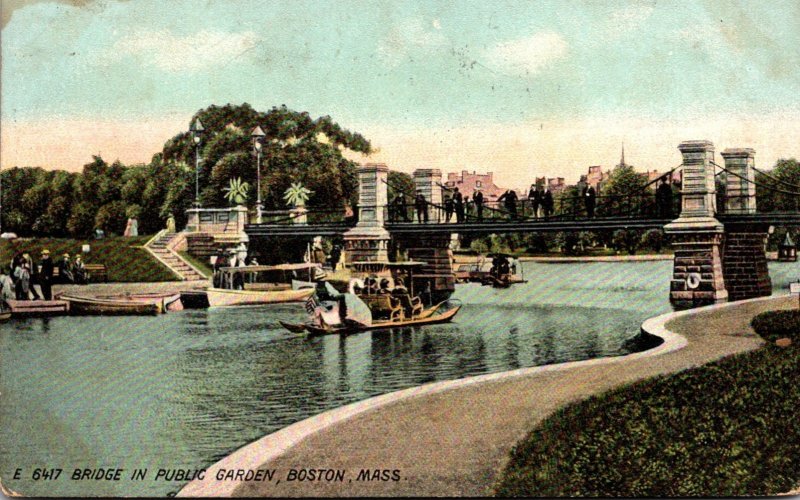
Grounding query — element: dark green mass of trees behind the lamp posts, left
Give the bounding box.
[2,104,372,237]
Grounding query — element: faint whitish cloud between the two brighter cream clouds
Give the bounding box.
[378,18,447,66]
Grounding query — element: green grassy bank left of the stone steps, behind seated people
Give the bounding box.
[0,236,177,282]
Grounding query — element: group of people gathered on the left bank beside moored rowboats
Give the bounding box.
[0,249,89,300]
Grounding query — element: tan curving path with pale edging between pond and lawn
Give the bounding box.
[181,297,796,496]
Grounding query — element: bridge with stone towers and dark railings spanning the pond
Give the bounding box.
[244,141,800,308]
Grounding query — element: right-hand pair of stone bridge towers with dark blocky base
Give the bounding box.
[664,141,771,308]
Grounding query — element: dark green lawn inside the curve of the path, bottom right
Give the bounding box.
[495,311,800,497]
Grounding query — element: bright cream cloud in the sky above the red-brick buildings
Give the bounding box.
[485,31,567,76]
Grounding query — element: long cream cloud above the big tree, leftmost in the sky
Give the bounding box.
[101,30,260,72]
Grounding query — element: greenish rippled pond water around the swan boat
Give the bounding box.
[0,261,797,496]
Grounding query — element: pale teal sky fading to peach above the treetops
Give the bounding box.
[0,0,800,187]
